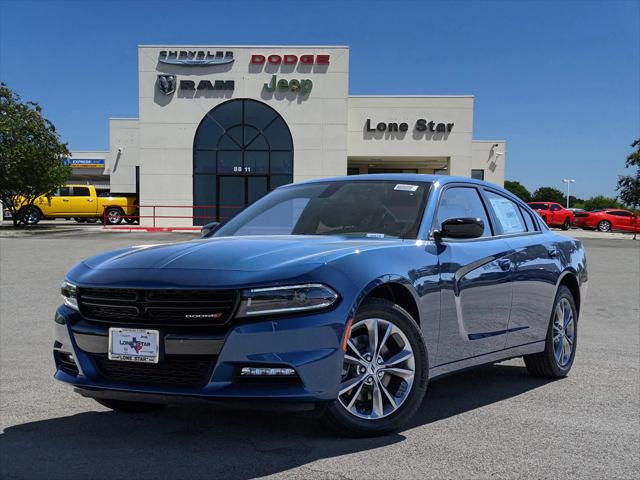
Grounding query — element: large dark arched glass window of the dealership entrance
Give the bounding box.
[193,99,293,225]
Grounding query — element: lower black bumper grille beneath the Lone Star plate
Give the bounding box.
[91,355,215,388]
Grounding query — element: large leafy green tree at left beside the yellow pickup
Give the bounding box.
[0,83,71,225]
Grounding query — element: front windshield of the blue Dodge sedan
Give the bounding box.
[214,180,431,238]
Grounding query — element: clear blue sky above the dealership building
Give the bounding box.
[0,0,640,197]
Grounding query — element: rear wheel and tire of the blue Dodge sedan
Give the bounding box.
[524,285,578,378]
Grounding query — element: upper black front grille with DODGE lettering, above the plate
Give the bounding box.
[78,287,238,325]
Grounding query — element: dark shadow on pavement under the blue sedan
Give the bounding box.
[0,365,546,479]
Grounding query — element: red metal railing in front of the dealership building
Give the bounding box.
[102,205,244,232]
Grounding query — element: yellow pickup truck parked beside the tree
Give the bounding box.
[15,185,136,225]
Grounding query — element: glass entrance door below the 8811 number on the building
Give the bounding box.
[216,175,269,222]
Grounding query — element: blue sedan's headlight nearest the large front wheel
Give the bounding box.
[237,283,338,317]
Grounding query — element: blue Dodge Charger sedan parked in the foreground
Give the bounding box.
[54,175,587,435]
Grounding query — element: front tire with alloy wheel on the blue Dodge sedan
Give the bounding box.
[323,299,429,437]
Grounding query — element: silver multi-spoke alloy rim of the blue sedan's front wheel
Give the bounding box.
[338,318,415,420]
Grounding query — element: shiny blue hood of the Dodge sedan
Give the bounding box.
[83,236,401,272]
